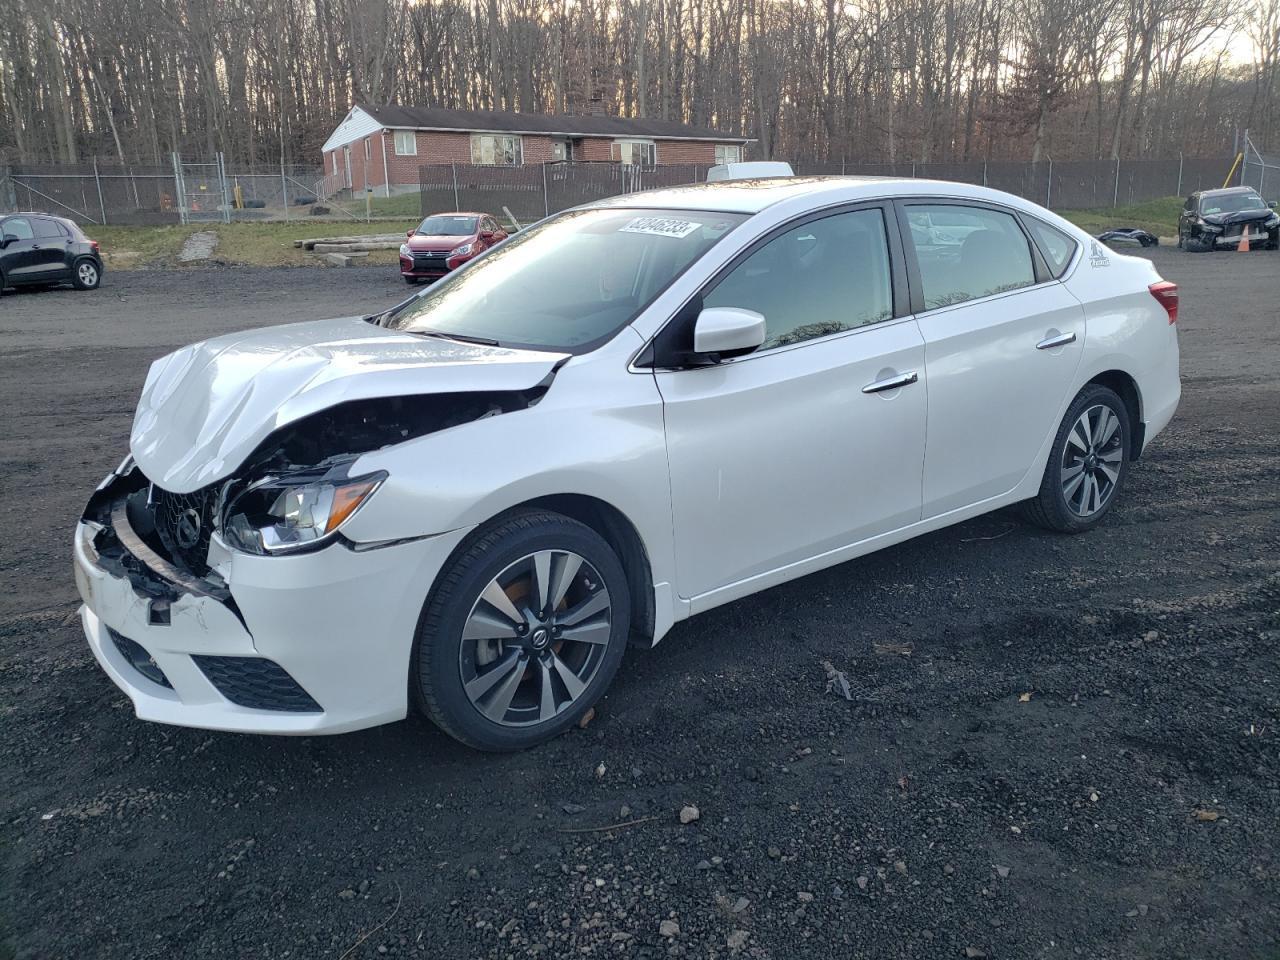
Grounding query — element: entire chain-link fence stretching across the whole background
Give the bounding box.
[0,154,1249,224]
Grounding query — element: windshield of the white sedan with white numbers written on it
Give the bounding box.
[384,209,746,352]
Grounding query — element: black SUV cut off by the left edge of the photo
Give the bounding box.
[0,214,102,293]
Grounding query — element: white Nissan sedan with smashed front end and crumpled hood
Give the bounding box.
[74,178,1180,750]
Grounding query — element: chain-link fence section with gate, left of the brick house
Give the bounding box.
[0,154,321,224]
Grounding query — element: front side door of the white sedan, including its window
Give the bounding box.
[655,206,927,598]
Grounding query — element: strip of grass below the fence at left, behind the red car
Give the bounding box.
[86,221,417,270]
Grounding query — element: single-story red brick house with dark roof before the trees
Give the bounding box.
[321,105,751,196]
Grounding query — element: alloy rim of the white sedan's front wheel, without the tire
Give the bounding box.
[458,550,613,727]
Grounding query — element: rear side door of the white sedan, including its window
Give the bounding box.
[899,200,1084,518]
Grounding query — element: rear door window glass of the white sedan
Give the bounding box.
[908,204,1036,310]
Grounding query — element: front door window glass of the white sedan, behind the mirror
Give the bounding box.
[703,210,893,349]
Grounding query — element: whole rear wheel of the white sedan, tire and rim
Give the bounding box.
[1023,384,1133,534]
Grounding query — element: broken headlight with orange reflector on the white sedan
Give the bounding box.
[221,472,387,556]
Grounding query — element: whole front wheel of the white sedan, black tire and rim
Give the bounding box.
[411,511,631,750]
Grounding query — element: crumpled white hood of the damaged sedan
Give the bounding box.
[129,317,567,493]
